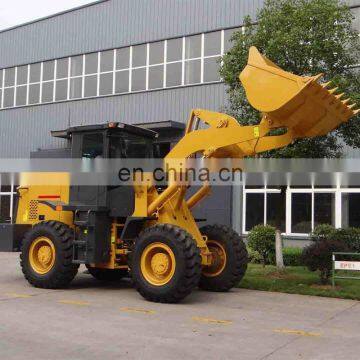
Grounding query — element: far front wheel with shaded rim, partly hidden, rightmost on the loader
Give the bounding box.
[199,225,248,291]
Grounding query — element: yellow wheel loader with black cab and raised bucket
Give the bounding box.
[2,47,359,303]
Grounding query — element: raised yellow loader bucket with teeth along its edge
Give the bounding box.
[240,47,359,139]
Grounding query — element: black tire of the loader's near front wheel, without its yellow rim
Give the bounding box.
[131,224,201,303]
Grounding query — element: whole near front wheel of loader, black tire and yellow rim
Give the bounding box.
[131,224,201,303]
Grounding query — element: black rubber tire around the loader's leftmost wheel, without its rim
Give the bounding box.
[20,221,79,289]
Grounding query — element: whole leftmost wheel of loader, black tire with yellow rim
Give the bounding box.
[20,221,79,289]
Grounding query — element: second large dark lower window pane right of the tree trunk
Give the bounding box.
[314,193,335,226]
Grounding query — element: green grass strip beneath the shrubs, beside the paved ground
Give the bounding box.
[239,264,360,300]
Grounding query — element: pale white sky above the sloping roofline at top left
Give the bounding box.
[0,0,94,30]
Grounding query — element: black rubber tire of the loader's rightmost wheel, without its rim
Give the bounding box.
[199,225,248,291]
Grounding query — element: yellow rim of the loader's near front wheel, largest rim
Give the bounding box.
[140,242,176,286]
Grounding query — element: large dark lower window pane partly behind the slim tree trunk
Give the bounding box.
[266,190,286,232]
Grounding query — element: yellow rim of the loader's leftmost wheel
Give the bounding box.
[29,236,56,275]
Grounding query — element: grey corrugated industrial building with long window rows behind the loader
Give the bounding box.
[0,0,360,242]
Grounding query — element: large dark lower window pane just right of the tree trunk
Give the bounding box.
[291,194,311,234]
